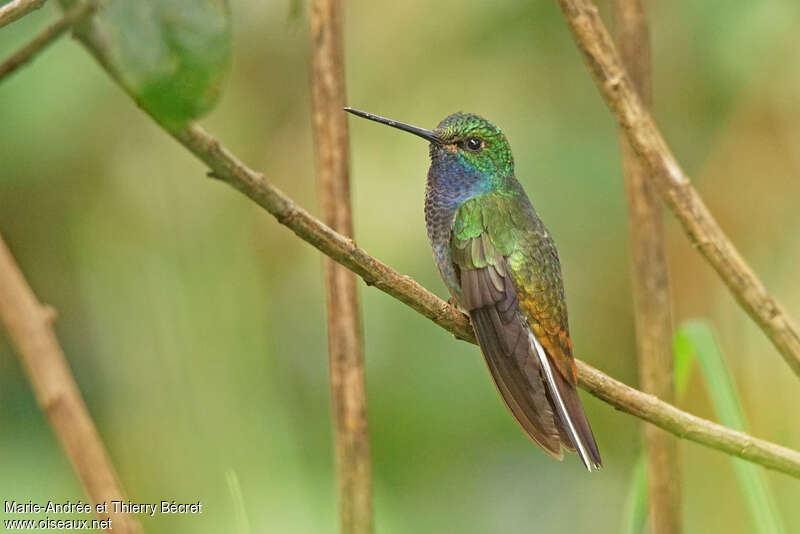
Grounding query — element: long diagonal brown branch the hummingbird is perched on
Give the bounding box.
[62,21,800,478]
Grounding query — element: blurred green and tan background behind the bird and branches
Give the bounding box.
[0,0,800,533]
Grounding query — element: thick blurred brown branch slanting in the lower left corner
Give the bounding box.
[0,237,141,534]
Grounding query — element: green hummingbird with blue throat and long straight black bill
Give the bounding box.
[344,107,601,471]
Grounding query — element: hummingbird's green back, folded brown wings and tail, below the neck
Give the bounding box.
[451,195,600,469]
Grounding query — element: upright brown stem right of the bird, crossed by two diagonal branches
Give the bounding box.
[615,0,681,534]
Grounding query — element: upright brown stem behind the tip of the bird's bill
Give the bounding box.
[310,0,372,534]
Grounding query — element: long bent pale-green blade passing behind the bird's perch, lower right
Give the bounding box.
[674,321,786,534]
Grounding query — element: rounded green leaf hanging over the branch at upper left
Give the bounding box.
[62,0,231,128]
